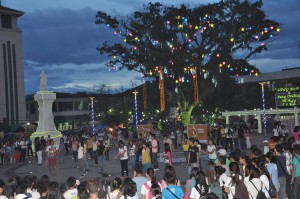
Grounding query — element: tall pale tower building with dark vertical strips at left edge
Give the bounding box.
[0,5,26,126]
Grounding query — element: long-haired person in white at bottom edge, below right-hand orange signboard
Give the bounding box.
[190,171,209,199]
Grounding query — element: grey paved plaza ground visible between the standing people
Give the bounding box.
[0,133,270,183]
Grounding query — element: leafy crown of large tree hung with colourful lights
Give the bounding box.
[96,0,280,123]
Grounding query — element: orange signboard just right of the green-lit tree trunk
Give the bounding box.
[187,124,209,141]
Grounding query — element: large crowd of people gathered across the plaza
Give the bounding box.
[0,123,300,199]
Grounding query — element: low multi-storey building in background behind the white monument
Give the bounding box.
[26,92,125,131]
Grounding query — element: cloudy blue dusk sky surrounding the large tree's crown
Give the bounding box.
[2,0,300,94]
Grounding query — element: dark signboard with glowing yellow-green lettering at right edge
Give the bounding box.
[275,86,300,107]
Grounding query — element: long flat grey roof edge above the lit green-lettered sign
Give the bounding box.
[234,68,300,84]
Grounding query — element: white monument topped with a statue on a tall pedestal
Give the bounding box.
[31,71,62,146]
